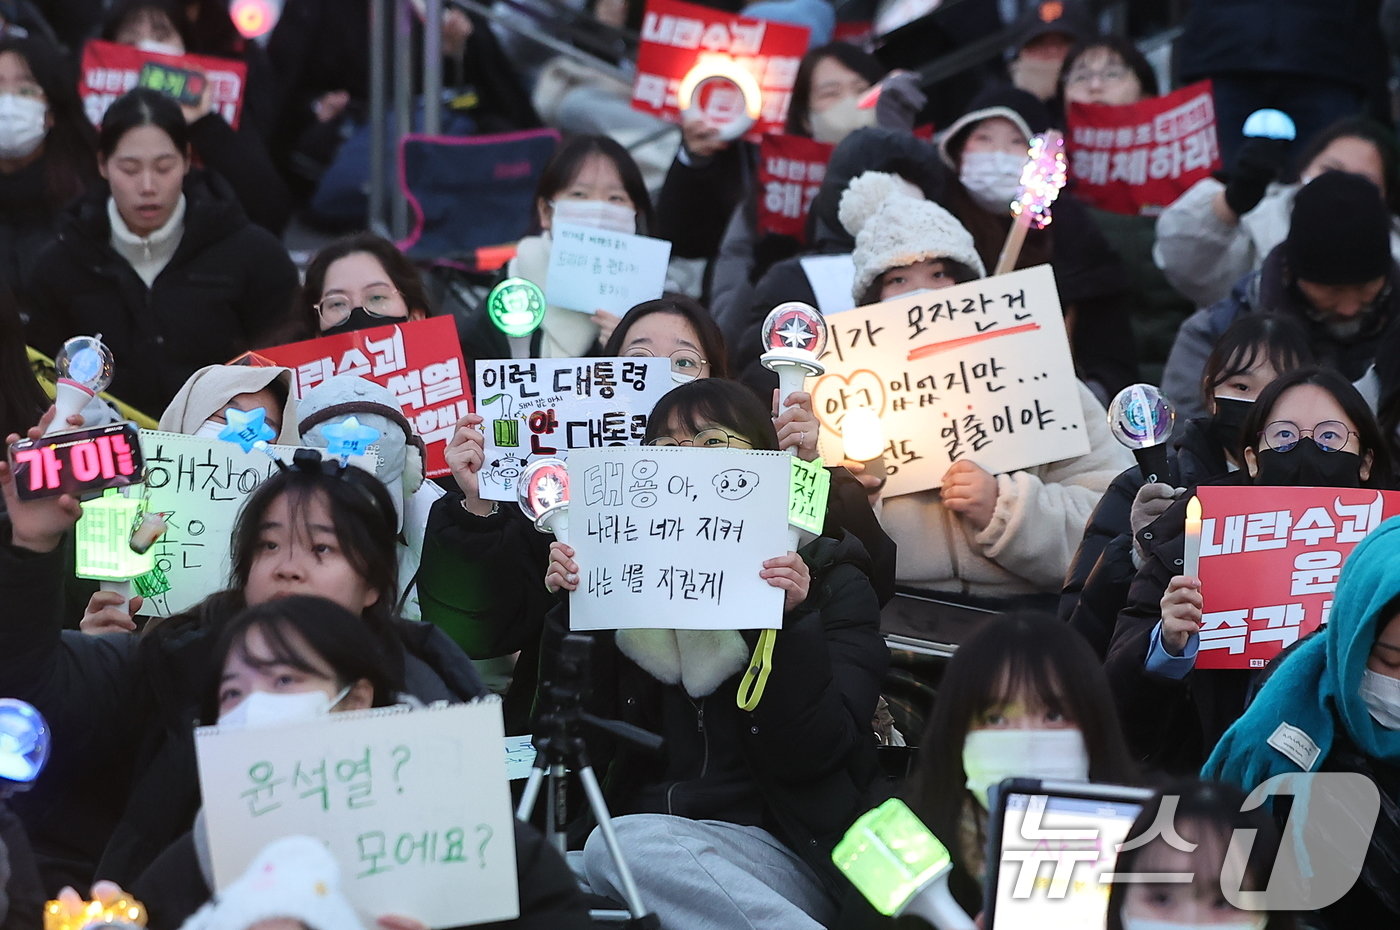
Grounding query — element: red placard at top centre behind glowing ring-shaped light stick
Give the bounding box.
[631,0,808,141]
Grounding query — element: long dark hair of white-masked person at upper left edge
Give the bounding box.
[0,36,98,209]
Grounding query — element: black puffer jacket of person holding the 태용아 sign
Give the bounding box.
[542,534,889,895]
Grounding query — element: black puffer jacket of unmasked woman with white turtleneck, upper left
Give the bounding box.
[27,172,297,416]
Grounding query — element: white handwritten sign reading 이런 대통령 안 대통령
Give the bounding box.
[476,359,675,500]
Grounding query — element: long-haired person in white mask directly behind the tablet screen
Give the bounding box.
[832,612,1138,930]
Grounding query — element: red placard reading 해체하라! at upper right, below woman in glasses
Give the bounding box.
[1065,81,1221,214]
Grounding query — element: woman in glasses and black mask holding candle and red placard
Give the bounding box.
[1105,367,1393,775]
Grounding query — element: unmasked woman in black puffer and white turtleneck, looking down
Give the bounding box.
[27,88,297,415]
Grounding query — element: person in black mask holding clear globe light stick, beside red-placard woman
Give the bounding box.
[1057,314,1313,658]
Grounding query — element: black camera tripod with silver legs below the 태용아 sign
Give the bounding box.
[515,633,662,930]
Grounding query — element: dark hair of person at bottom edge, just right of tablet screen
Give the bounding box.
[1106,779,1296,930]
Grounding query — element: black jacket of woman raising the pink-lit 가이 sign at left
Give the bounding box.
[0,537,484,888]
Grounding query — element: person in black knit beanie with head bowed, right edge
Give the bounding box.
[1162,171,1400,416]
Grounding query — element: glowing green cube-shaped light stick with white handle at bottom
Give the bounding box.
[832,798,976,930]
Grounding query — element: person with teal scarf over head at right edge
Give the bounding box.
[1201,520,1400,930]
